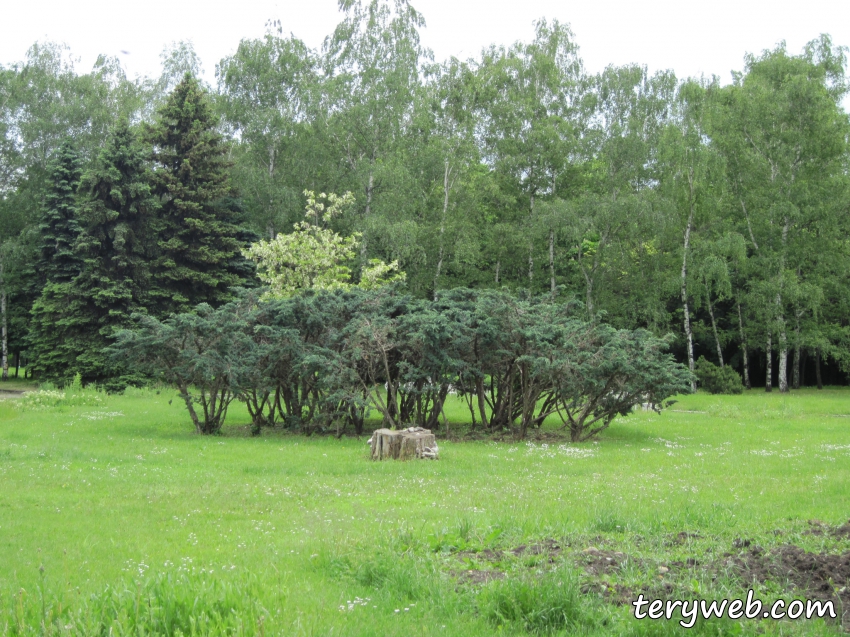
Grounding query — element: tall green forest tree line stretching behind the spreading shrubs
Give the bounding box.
[0,0,850,391]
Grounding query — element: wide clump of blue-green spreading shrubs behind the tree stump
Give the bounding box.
[113,286,691,441]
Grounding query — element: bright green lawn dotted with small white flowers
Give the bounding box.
[0,389,850,635]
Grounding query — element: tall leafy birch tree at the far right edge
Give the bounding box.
[718,36,847,392]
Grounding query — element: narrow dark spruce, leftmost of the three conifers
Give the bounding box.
[27,140,82,383]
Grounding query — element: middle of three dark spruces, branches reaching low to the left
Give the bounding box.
[34,120,157,388]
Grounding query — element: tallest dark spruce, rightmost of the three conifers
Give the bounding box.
[148,73,243,316]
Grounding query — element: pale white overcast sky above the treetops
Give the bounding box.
[0,0,850,90]
